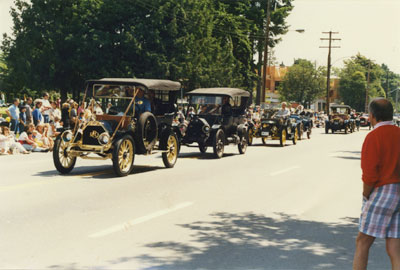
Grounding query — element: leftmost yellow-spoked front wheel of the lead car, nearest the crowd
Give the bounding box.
[53,137,76,174]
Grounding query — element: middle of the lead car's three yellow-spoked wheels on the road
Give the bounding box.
[112,135,135,176]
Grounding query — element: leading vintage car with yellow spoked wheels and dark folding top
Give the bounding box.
[53,78,181,176]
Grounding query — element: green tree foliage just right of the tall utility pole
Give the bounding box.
[339,54,386,111]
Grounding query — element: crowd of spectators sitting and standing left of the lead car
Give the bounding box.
[0,93,80,155]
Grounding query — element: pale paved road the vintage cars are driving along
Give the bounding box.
[0,129,389,270]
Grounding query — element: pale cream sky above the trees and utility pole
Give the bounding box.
[0,0,400,74]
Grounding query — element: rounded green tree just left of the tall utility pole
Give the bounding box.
[278,59,325,106]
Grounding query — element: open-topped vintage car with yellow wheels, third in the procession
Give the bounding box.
[248,109,301,146]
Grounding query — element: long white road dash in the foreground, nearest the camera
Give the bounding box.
[89,202,193,238]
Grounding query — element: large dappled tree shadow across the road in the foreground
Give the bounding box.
[48,212,390,270]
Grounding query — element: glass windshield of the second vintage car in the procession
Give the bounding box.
[189,95,222,115]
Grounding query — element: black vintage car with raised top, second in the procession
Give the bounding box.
[180,88,250,158]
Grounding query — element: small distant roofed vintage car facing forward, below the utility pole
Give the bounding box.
[325,104,351,134]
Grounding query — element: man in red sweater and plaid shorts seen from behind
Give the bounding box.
[353,99,400,270]
